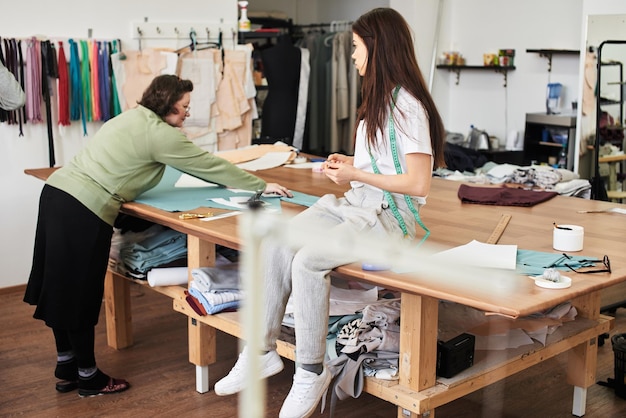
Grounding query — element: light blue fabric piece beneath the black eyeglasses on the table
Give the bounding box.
[515,250,602,276]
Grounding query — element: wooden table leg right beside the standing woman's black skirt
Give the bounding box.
[104,270,133,350]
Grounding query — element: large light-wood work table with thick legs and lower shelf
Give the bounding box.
[26,167,626,417]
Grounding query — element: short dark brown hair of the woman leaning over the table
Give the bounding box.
[137,74,193,118]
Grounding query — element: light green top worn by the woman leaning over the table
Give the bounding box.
[47,105,266,225]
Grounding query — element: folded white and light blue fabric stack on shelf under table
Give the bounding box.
[188,264,243,315]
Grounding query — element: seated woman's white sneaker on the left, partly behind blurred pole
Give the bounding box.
[213,347,285,396]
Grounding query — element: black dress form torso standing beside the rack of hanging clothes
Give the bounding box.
[261,35,302,145]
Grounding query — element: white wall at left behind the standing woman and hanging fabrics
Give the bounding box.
[0,0,238,288]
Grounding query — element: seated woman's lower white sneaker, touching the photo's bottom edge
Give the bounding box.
[278,366,332,418]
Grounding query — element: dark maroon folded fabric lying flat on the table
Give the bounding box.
[458,184,558,207]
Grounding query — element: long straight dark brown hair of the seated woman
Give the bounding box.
[352,7,445,168]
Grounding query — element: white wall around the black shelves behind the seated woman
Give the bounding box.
[433,0,582,146]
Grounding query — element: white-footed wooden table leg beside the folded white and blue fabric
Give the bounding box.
[187,235,217,393]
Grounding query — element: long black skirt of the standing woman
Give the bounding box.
[24,185,113,330]
